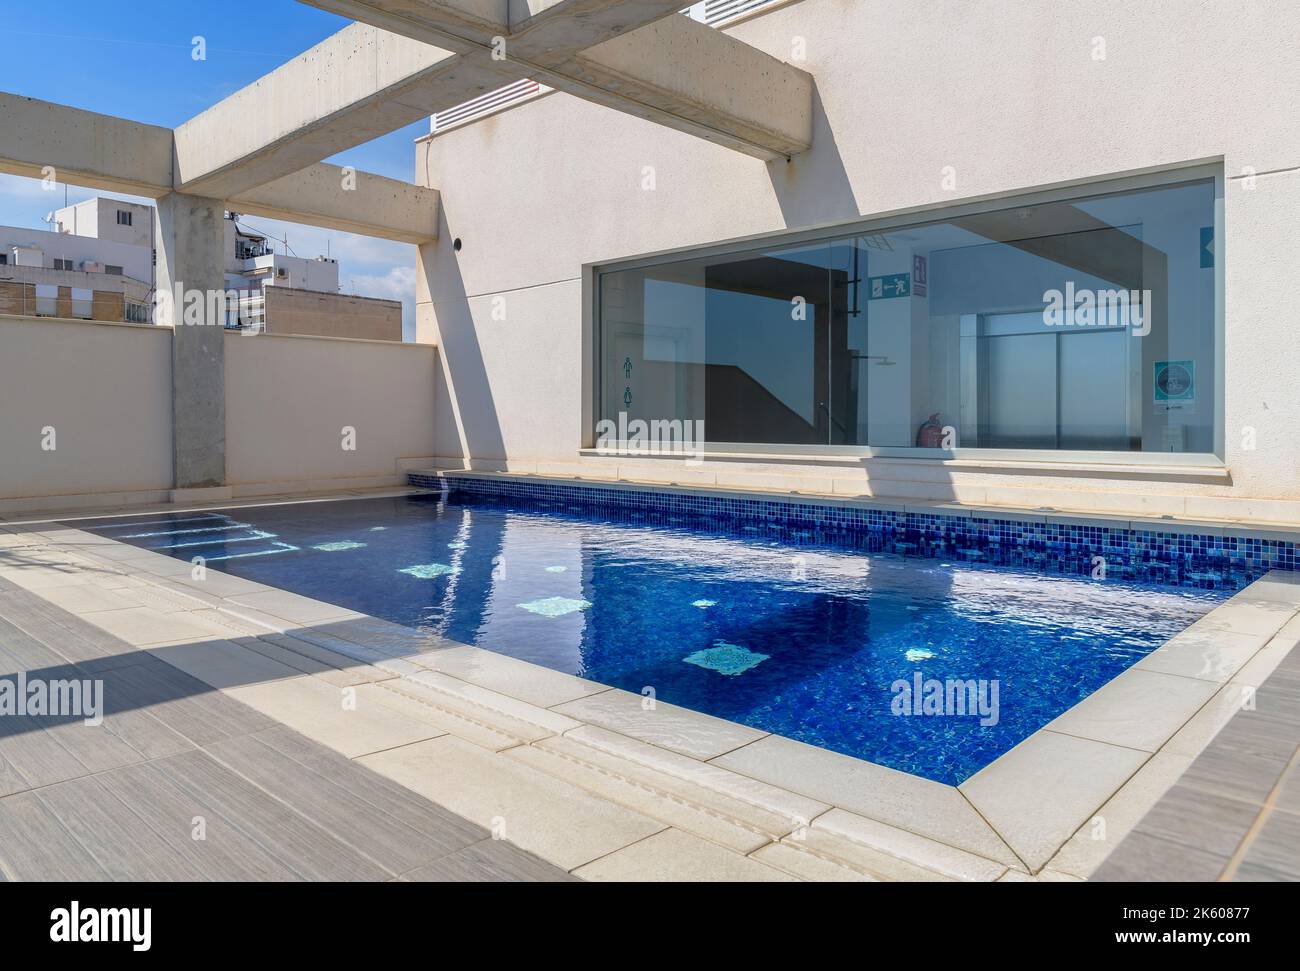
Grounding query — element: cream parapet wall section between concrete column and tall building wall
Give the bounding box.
[226,333,437,497]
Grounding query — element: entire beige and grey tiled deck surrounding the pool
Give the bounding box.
[0,490,1300,881]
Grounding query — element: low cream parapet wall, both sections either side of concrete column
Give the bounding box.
[0,317,438,517]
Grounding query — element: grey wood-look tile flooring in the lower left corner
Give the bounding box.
[0,578,575,881]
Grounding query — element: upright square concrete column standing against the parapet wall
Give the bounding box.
[155,192,226,498]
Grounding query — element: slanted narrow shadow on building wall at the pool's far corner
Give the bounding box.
[420,203,506,461]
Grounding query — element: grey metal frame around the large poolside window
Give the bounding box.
[580,160,1226,471]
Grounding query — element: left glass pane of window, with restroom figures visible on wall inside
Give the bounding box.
[599,243,831,445]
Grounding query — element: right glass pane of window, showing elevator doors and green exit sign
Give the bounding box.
[831,179,1217,452]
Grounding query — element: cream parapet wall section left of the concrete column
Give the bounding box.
[0,317,172,515]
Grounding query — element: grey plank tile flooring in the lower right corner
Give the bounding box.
[1092,636,1300,881]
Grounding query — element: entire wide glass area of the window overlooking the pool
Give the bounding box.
[597,178,1218,452]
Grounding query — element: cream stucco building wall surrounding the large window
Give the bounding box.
[416,0,1300,520]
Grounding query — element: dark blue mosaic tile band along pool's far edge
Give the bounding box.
[408,473,1297,590]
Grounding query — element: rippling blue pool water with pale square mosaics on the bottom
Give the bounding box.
[91,495,1226,785]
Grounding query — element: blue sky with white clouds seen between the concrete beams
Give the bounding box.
[0,0,429,331]
